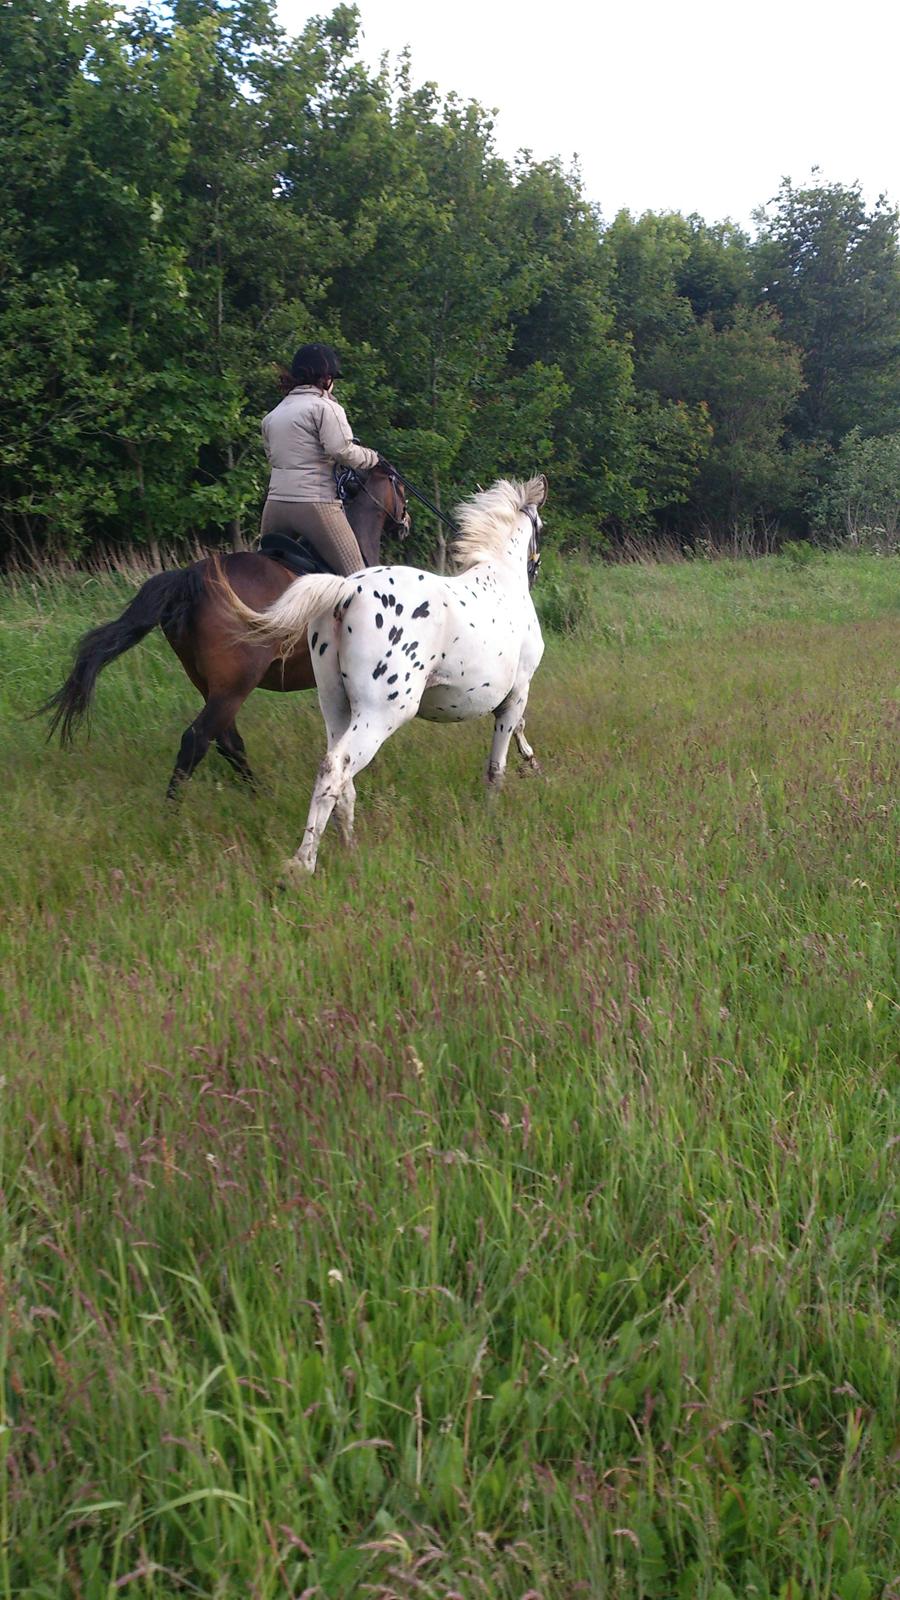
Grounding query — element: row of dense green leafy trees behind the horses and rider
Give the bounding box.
[0,0,900,558]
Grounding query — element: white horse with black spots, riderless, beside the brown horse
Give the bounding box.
[223,477,548,872]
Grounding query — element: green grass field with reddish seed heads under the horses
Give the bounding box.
[0,557,900,1600]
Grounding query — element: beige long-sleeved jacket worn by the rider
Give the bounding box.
[263,384,378,502]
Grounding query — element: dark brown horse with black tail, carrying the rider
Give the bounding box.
[40,466,408,800]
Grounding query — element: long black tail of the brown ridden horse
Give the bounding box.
[34,566,203,744]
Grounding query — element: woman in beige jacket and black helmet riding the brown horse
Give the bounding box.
[259,344,380,576]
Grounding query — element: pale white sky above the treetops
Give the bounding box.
[279,0,900,226]
